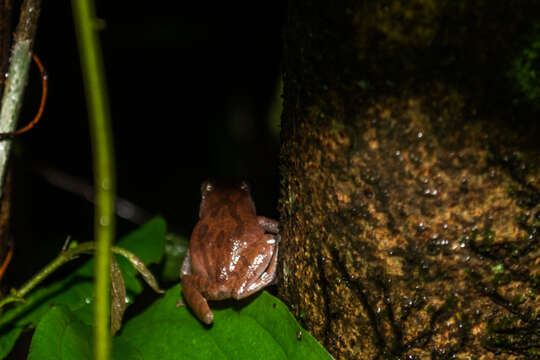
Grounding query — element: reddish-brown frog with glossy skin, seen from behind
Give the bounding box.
[177,180,280,325]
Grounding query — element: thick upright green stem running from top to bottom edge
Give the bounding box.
[71,0,114,360]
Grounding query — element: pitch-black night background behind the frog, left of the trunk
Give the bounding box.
[7,1,285,285]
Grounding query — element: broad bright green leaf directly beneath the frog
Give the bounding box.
[115,285,331,360]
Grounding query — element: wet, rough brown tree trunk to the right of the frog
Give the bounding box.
[279,0,540,359]
